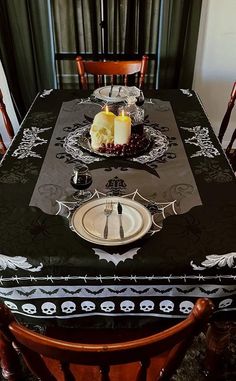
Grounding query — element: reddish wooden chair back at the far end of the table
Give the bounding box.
[76,56,148,89]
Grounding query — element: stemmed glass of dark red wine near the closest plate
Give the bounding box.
[70,164,92,201]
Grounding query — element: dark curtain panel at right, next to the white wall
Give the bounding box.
[157,0,202,88]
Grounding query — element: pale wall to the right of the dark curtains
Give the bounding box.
[193,0,236,146]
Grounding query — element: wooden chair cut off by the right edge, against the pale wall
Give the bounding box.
[218,82,236,172]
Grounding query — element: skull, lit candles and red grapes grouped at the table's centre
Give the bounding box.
[90,106,149,156]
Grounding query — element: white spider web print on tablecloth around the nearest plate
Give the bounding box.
[56,189,177,235]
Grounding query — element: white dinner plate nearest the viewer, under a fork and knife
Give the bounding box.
[71,197,152,246]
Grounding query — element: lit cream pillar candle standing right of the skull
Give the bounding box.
[114,110,131,144]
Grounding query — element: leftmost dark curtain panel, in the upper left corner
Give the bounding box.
[0,0,55,117]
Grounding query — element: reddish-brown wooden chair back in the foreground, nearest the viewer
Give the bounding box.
[0,298,213,381]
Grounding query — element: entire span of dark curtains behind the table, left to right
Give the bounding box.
[0,0,202,115]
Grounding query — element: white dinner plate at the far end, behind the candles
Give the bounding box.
[93,85,139,103]
